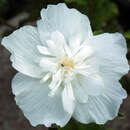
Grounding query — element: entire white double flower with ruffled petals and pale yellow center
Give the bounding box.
[2,4,129,127]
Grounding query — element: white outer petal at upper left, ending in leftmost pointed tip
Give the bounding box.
[2,26,42,77]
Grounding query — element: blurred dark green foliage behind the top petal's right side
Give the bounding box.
[65,0,118,31]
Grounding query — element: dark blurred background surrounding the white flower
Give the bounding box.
[0,0,130,130]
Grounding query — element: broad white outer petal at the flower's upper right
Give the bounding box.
[89,33,129,80]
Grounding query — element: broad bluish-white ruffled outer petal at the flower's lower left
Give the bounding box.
[12,73,71,127]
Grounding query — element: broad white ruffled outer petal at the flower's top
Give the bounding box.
[38,4,92,43]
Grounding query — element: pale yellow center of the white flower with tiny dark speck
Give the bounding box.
[60,56,74,69]
